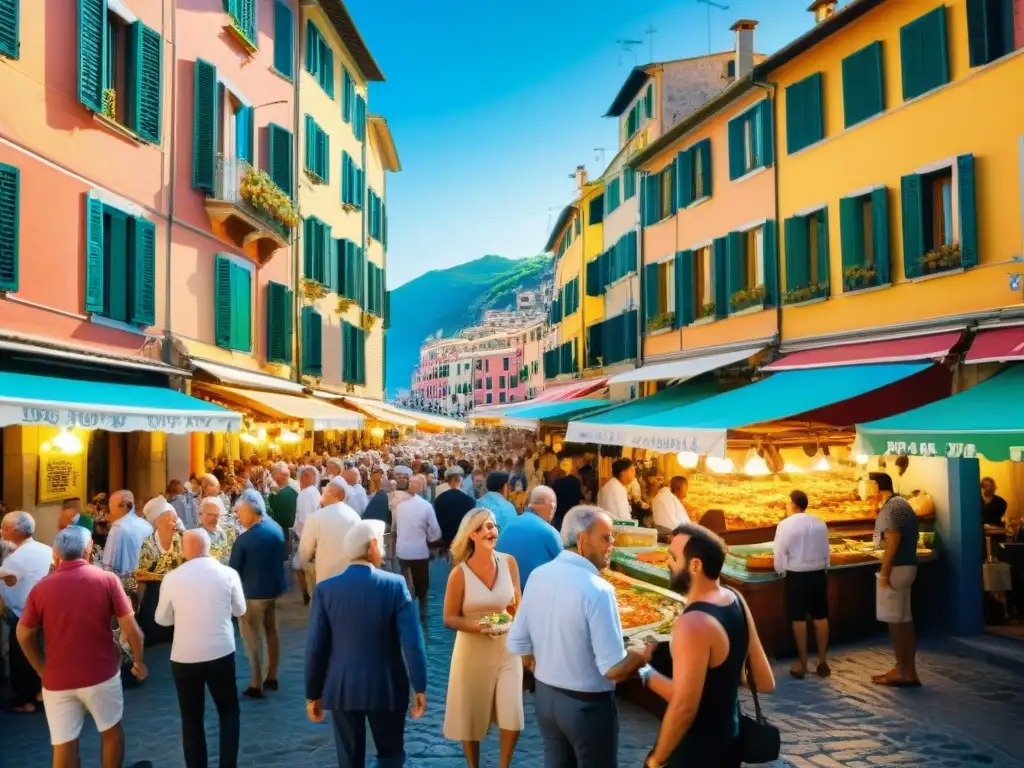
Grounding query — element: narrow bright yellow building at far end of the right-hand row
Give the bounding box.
[544,166,604,384]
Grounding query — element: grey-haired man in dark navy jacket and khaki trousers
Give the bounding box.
[228,488,285,698]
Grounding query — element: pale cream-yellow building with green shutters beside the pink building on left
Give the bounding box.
[297,3,399,399]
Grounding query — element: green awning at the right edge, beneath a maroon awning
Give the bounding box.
[857,366,1024,461]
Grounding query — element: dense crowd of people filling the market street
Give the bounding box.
[0,433,937,768]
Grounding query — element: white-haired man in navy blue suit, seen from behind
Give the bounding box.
[306,520,427,768]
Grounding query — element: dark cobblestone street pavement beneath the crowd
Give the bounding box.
[0,562,1024,768]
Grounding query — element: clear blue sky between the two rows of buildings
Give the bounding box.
[346,0,835,288]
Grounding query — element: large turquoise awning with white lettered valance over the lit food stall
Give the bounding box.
[566,362,931,456]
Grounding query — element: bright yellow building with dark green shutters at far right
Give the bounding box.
[770,0,1024,350]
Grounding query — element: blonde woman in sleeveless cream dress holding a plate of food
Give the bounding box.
[444,507,523,768]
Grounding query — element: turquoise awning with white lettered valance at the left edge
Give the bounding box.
[0,372,242,434]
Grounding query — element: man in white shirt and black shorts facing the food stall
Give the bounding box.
[773,490,831,680]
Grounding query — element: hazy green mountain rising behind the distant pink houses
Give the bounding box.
[386,255,552,397]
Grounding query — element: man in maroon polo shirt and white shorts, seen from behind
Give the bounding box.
[17,525,153,768]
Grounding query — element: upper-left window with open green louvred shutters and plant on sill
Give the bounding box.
[75,0,160,143]
